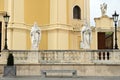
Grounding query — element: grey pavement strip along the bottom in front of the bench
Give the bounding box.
[0,76,120,80]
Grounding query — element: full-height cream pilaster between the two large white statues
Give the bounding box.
[48,0,68,49]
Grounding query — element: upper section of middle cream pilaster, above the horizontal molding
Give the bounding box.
[50,0,66,24]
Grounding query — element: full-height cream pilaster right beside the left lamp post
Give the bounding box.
[3,0,27,50]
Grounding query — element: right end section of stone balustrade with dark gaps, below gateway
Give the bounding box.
[91,49,120,64]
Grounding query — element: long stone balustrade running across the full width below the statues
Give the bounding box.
[0,50,120,64]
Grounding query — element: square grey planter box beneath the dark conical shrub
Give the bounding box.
[3,66,16,77]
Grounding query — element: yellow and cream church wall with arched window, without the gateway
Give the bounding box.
[0,0,90,50]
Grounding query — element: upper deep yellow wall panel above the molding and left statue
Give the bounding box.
[24,0,50,25]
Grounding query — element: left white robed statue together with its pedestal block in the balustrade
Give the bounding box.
[28,22,41,63]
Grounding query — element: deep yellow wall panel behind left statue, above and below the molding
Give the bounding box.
[24,0,50,50]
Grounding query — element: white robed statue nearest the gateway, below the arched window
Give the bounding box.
[81,23,92,49]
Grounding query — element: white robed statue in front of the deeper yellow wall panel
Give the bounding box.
[30,23,41,50]
